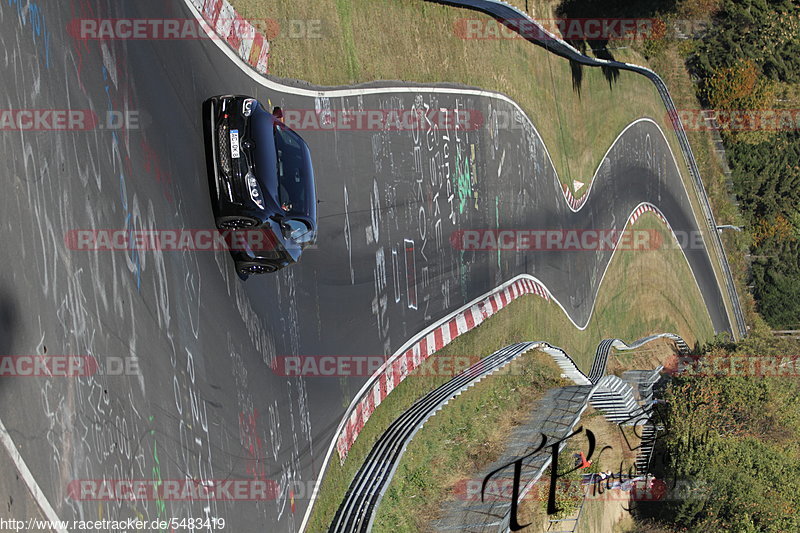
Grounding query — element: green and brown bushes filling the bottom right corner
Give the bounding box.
[648,330,800,533]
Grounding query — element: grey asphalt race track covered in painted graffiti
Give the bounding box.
[0,0,731,532]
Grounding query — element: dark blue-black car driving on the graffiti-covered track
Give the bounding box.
[203,95,317,274]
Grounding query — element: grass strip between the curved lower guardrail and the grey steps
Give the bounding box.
[373,351,572,533]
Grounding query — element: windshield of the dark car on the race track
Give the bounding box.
[275,123,313,213]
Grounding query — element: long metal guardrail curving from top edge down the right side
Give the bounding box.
[428,0,747,337]
